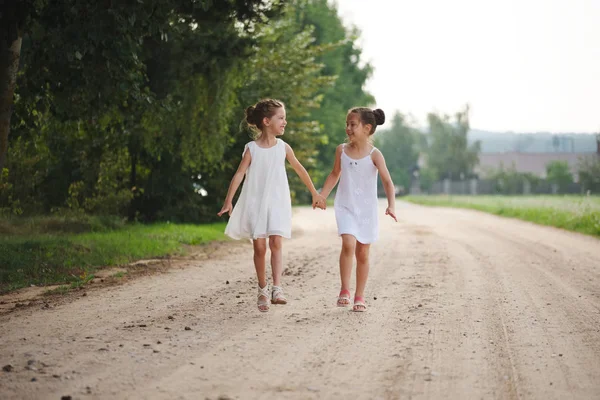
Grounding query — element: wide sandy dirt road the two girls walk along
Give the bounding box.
[0,202,600,400]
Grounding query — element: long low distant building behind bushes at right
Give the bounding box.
[475,152,600,180]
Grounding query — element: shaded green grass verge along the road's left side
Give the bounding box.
[0,223,225,293]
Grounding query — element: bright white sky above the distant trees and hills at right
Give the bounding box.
[335,0,600,132]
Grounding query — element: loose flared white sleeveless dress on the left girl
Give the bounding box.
[225,139,292,239]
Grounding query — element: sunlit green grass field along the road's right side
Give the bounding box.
[403,195,600,237]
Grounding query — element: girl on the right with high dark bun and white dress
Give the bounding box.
[321,107,396,311]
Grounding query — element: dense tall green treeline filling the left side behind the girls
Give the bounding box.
[0,0,374,222]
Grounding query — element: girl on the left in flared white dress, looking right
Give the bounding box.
[217,99,325,312]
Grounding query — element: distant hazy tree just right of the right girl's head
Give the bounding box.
[375,112,420,190]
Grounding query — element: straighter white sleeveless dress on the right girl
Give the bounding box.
[334,145,379,244]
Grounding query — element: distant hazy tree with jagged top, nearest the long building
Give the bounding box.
[427,107,481,180]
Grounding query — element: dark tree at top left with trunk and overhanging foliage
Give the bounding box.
[0,0,278,178]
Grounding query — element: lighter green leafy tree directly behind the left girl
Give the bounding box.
[206,4,335,212]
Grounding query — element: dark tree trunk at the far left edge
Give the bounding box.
[0,35,22,176]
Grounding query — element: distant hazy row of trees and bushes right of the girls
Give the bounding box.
[376,107,600,194]
